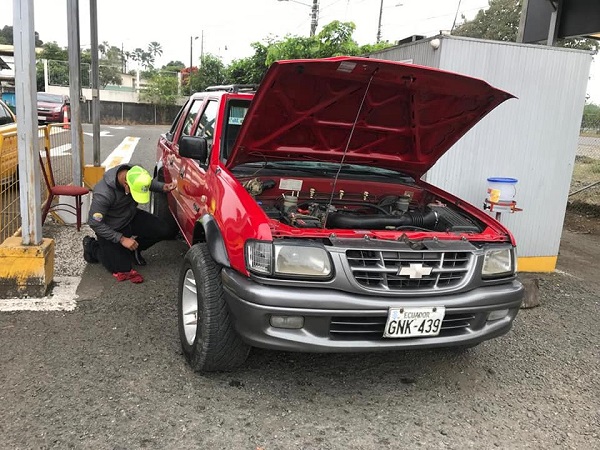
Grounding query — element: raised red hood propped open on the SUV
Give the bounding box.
[227,56,513,178]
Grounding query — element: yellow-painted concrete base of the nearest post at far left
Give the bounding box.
[0,237,54,298]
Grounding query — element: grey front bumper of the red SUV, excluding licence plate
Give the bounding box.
[222,269,524,352]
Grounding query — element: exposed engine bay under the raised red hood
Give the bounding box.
[242,178,484,233]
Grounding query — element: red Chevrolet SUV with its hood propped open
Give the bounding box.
[151,57,524,371]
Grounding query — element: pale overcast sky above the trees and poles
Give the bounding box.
[0,0,600,104]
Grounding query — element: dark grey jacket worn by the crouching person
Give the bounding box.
[88,164,164,243]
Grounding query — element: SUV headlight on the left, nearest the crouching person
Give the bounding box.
[246,241,331,278]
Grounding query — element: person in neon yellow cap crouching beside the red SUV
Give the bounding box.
[83,164,177,283]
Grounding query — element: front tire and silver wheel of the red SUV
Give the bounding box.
[177,243,250,372]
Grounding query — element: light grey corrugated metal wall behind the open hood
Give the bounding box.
[424,37,591,257]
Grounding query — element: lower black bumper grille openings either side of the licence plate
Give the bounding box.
[329,313,475,341]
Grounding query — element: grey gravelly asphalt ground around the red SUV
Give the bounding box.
[0,213,600,450]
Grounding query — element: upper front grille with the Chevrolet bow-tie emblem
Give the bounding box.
[346,250,473,291]
